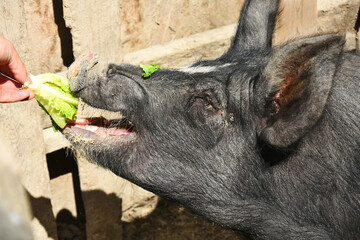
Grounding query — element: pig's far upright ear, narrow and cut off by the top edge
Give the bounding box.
[229,0,279,52]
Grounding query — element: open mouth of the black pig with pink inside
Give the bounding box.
[63,117,136,143]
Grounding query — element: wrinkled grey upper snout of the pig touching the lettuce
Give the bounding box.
[70,61,147,115]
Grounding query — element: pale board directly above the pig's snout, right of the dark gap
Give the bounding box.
[63,0,122,62]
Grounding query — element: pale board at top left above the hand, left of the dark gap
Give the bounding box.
[0,0,65,74]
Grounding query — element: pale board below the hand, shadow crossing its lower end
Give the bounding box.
[0,99,57,239]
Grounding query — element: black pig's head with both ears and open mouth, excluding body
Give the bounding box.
[64,0,343,234]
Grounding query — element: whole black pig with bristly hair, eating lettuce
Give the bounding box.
[63,0,360,240]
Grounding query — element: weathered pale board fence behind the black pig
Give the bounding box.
[0,0,360,240]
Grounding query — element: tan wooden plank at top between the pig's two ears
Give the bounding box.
[274,0,317,44]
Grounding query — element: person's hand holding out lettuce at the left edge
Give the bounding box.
[0,36,34,102]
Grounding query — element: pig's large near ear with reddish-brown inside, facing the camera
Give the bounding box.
[259,34,344,147]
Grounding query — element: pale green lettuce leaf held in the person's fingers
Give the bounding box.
[24,73,79,129]
